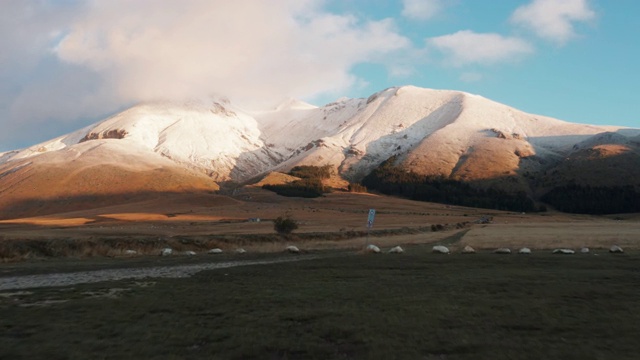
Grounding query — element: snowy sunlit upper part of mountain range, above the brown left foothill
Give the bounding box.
[0,86,640,186]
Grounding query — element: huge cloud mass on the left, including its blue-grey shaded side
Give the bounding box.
[0,0,412,151]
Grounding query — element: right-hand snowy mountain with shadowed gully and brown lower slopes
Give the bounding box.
[256,86,639,190]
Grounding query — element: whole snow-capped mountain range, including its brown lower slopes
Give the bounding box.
[0,86,640,217]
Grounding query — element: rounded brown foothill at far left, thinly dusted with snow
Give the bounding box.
[0,140,219,217]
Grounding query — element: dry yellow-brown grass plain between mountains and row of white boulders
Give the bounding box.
[0,187,640,256]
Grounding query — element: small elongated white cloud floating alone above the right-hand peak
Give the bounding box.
[427,30,534,66]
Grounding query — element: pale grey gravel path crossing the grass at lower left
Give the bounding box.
[0,255,326,291]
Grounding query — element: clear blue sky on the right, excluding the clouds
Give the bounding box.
[334,0,640,127]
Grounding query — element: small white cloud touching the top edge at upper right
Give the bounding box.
[510,0,596,44]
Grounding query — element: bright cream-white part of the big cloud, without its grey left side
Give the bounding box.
[52,0,410,107]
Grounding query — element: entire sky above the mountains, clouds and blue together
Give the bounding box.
[0,0,640,151]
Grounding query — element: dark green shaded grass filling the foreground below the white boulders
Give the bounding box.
[0,246,640,359]
